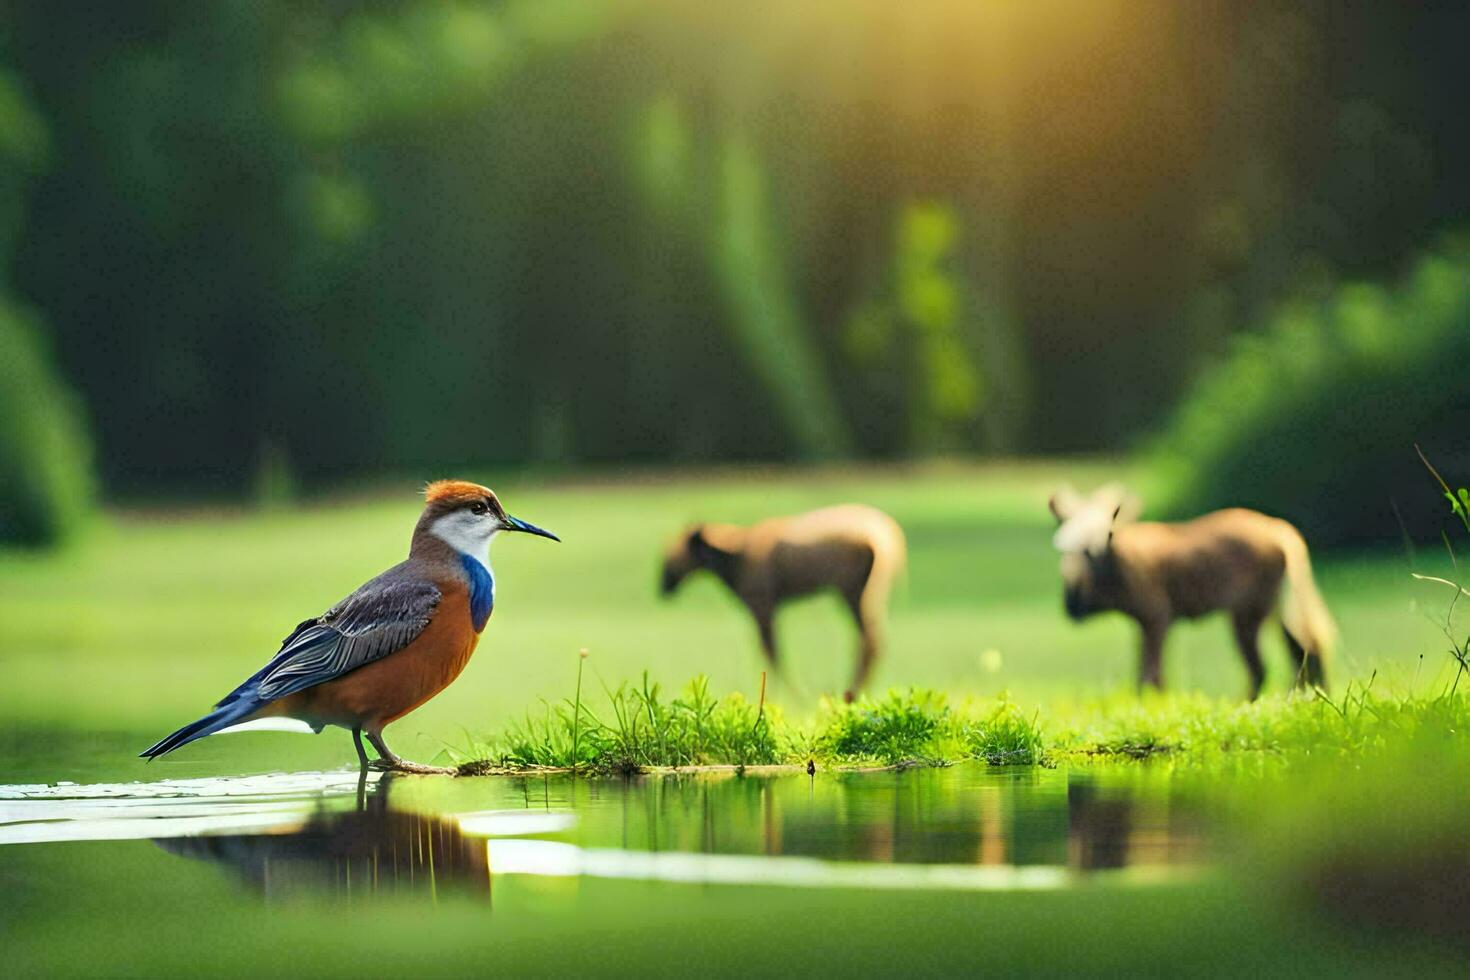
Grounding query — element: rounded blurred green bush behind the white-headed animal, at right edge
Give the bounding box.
[1154,239,1470,544]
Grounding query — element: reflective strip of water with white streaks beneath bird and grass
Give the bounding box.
[0,765,1207,899]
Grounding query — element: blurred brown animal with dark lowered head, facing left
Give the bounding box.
[663,504,904,701]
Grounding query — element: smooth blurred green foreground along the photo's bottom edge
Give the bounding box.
[0,840,1458,977]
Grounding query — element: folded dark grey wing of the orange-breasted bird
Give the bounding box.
[256,564,442,701]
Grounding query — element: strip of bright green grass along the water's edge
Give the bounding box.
[450,674,1470,773]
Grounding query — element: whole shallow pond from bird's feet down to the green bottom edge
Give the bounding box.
[0,739,1444,976]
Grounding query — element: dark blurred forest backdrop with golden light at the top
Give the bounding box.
[0,0,1470,539]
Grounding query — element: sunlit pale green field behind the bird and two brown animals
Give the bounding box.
[0,463,1446,768]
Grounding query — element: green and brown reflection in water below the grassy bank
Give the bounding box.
[546,767,1207,880]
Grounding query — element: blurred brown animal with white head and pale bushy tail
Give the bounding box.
[1050,486,1336,699]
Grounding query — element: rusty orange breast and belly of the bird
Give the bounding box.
[260,588,479,730]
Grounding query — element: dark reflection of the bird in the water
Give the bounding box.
[154,777,490,899]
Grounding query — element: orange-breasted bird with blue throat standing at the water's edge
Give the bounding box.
[140,480,560,773]
